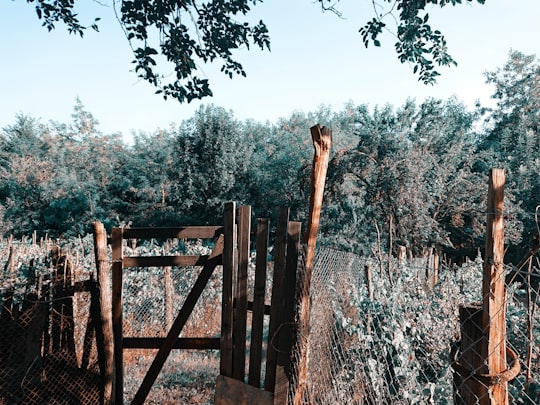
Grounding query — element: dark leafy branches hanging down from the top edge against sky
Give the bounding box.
[27,0,485,102]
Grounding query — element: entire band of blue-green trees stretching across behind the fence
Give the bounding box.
[0,51,540,257]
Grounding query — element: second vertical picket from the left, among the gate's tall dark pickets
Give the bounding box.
[233,205,251,381]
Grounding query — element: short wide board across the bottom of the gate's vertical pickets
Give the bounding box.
[214,375,274,405]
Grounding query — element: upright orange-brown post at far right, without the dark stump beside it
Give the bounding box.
[481,169,508,405]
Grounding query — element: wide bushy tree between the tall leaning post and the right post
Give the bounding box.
[321,99,498,257]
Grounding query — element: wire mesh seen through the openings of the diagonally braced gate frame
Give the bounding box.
[123,241,222,404]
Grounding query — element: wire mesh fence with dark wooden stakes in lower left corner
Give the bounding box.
[0,235,100,404]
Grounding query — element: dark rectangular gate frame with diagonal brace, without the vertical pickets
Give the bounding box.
[111,225,226,405]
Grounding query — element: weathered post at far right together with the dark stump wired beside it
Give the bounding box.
[454,169,519,405]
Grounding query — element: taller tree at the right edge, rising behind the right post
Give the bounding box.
[480,51,540,260]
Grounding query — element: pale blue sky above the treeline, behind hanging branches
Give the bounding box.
[0,0,540,141]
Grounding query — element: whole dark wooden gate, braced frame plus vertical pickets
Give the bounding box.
[107,203,301,404]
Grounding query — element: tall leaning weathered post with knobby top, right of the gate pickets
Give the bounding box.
[294,125,332,405]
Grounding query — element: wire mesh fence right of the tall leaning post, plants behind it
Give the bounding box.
[289,248,540,404]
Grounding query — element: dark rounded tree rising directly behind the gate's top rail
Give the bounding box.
[167,105,253,225]
